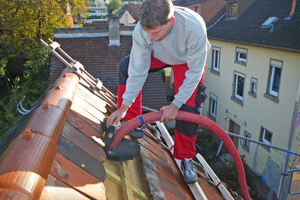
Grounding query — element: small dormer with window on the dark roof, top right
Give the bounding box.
[226,0,255,20]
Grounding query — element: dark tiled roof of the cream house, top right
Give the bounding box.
[207,0,300,52]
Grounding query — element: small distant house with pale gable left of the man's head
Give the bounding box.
[116,4,141,26]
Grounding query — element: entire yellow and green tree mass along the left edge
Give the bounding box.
[0,0,87,136]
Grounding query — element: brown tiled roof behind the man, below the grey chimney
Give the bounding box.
[49,28,168,110]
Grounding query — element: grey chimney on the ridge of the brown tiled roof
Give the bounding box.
[108,15,120,46]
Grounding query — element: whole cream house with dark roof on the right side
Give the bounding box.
[203,0,300,199]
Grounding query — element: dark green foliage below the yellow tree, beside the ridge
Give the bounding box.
[0,47,50,136]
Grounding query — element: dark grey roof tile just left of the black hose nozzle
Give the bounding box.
[62,122,106,162]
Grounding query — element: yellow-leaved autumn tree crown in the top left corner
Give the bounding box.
[0,0,87,53]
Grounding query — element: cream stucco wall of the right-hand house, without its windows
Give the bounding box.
[203,40,300,198]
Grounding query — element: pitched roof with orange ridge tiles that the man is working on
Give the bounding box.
[0,62,223,200]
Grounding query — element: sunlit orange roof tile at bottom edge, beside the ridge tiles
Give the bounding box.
[40,174,89,200]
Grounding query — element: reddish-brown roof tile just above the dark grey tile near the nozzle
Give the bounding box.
[67,111,105,146]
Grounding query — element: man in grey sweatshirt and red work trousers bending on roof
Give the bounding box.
[106,0,210,183]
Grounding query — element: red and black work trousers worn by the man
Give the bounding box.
[118,56,205,160]
